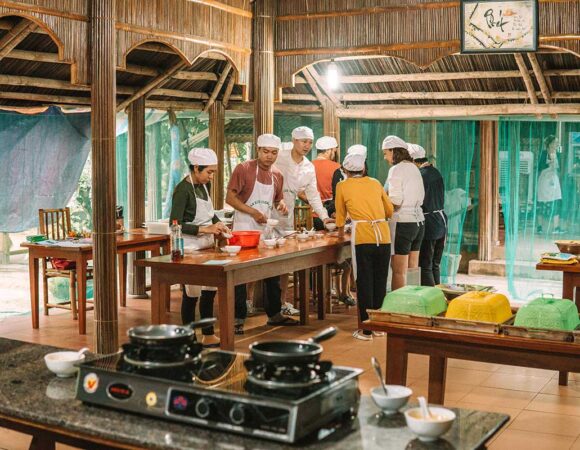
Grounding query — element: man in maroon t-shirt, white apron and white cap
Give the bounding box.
[226,134,298,334]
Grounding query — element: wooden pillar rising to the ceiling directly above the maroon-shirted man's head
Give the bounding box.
[253,0,276,142]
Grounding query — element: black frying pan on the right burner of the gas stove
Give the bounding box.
[250,327,336,364]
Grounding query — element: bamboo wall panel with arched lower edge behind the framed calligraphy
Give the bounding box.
[276,0,580,87]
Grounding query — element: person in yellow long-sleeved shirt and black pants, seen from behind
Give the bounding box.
[335,146,393,341]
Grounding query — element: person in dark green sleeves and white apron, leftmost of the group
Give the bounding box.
[169,148,229,347]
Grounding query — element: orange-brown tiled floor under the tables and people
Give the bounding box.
[0,293,580,450]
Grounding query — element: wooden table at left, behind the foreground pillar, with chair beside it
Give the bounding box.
[20,229,170,334]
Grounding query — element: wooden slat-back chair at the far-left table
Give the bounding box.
[38,208,93,320]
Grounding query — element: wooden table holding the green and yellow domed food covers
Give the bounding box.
[366,321,580,404]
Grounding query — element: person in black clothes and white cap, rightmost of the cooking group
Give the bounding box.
[408,144,447,286]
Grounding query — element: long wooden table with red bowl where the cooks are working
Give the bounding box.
[135,236,350,350]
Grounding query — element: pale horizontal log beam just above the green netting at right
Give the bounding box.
[336,103,580,120]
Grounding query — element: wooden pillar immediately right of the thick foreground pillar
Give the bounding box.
[127,96,148,298]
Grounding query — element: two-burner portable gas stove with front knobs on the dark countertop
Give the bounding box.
[77,348,362,442]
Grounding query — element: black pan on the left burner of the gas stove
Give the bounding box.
[127,317,216,346]
